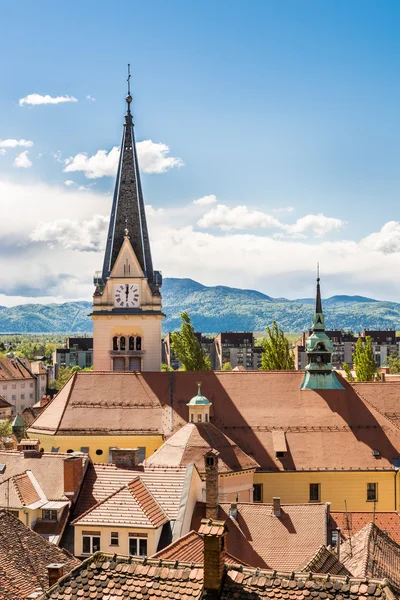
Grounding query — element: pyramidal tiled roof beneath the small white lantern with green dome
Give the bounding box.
[145,423,259,474]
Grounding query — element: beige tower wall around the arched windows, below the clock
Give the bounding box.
[93,314,162,371]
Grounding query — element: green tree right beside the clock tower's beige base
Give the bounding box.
[171,312,211,371]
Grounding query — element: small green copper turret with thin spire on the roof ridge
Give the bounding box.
[300,269,344,390]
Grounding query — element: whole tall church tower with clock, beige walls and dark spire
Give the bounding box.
[91,73,164,371]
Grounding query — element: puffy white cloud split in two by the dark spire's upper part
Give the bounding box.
[64,140,183,179]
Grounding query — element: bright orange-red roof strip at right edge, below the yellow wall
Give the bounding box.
[329,511,400,544]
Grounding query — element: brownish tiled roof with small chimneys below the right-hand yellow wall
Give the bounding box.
[191,502,328,571]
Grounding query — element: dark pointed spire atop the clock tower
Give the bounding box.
[102,65,153,283]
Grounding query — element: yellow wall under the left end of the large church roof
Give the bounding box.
[28,433,164,463]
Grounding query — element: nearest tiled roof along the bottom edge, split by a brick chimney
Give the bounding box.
[39,553,394,600]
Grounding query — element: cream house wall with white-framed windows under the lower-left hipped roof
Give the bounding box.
[74,524,162,556]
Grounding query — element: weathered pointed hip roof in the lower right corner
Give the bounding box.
[341,523,400,592]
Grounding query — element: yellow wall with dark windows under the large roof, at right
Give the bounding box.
[254,471,400,512]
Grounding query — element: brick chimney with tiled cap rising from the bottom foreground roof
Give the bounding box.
[199,519,226,597]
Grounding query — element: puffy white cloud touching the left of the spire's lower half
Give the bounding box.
[30,215,108,252]
